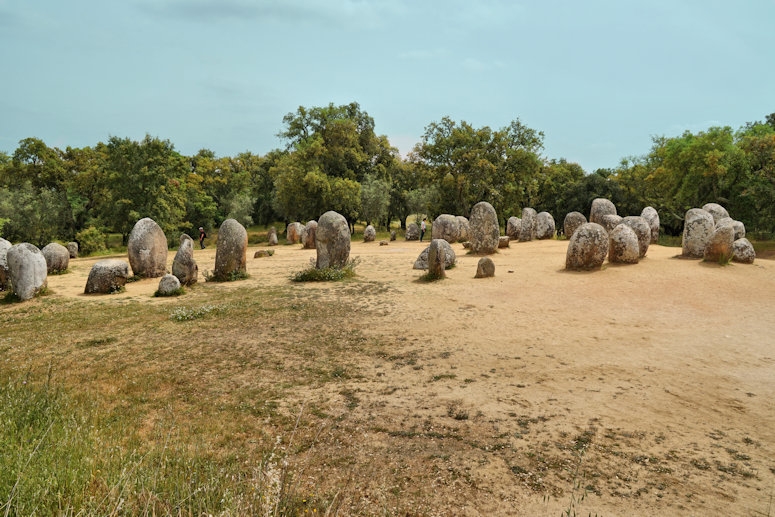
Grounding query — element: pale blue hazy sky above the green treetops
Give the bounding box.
[0,0,775,172]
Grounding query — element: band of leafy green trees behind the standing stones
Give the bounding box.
[0,102,775,246]
